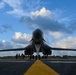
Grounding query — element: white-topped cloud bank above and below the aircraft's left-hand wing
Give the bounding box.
[0,31,31,56]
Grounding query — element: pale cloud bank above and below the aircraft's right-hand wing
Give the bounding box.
[51,36,76,56]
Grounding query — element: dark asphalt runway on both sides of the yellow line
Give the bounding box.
[0,60,76,75]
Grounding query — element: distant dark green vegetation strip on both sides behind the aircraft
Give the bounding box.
[0,55,76,59]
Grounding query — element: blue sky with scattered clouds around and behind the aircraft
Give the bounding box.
[0,0,76,56]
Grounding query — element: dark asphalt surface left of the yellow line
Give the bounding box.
[0,60,34,75]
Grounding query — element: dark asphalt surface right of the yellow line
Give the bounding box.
[43,60,76,75]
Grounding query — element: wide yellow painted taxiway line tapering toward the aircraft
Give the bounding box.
[24,60,60,75]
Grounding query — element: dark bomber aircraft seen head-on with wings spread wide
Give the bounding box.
[0,29,76,59]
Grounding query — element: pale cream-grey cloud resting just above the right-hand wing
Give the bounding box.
[52,36,76,48]
